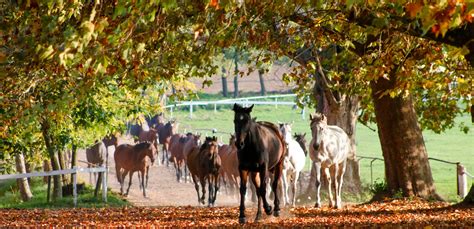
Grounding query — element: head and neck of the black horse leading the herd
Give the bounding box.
[232,103,253,149]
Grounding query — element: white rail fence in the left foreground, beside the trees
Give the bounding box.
[0,167,107,207]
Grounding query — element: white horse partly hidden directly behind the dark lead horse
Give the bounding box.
[280,123,306,207]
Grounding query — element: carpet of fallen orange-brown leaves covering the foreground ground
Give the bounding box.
[0,200,474,228]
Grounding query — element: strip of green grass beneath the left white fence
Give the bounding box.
[0,177,130,209]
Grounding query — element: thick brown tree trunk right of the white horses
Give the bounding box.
[370,74,440,199]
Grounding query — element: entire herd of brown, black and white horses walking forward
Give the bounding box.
[86,104,350,223]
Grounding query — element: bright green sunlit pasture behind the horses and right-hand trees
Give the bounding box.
[168,95,474,202]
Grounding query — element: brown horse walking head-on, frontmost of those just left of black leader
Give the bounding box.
[186,137,221,207]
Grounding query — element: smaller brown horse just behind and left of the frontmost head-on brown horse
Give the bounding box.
[169,133,193,182]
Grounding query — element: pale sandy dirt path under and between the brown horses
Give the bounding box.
[78,136,244,207]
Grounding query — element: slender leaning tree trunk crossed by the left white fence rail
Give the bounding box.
[41,121,62,200]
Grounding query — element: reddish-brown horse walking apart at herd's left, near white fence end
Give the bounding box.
[114,142,156,197]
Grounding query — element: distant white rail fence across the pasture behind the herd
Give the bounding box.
[165,94,305,119]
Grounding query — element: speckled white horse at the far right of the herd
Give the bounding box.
[309,113,350,208]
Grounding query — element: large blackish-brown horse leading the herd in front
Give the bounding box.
[233,104,286,223]
